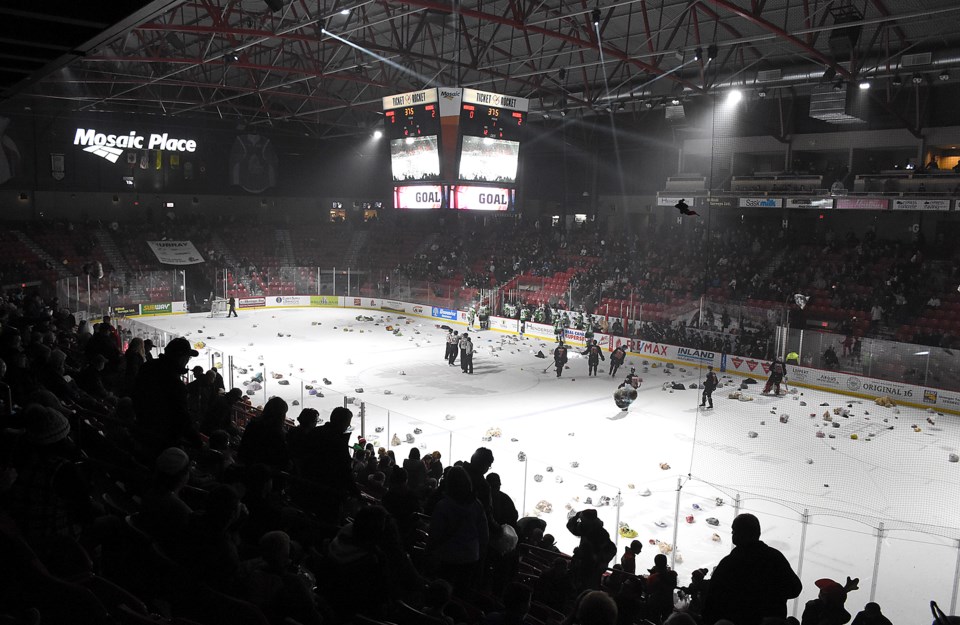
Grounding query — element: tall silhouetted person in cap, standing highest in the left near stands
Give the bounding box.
[133,337,200,458]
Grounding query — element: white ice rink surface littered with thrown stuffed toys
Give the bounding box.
[137,308,960,624]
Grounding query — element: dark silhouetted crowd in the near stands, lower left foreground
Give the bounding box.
[0,293,908,625]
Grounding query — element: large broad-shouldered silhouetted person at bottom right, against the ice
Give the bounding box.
[703,514,803,625]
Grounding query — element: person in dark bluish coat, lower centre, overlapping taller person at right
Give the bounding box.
[426,466,489,596]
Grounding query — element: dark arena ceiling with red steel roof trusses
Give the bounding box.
[0,0,960,136]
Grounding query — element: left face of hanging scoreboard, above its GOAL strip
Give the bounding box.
[383,89,440,182]
